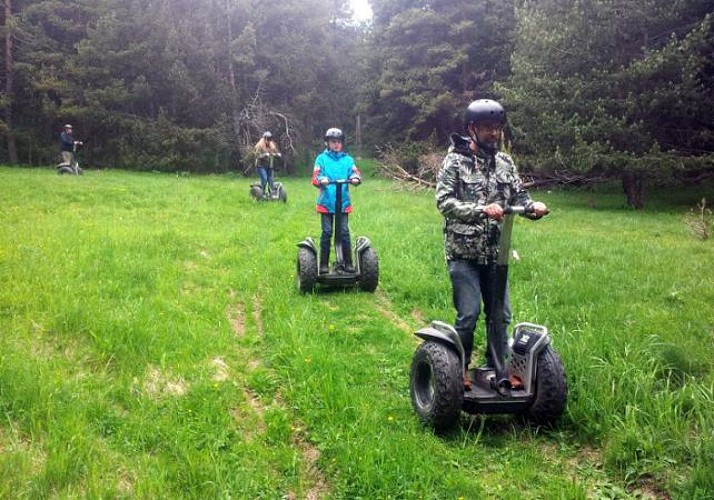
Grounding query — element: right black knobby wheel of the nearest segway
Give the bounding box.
[524,345,568,427]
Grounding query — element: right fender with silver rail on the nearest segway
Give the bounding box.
[508,323,550,394]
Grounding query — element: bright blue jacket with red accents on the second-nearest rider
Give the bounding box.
[312,149,362,214]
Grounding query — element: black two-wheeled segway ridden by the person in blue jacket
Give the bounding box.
[296,180,379,293]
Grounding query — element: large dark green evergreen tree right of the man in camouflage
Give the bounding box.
[497,0,714,206]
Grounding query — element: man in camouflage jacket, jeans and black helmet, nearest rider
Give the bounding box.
[436,99,547,388]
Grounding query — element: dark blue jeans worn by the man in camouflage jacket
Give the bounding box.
[448,260,511,367]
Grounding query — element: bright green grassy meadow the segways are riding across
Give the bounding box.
[0,167,714,500]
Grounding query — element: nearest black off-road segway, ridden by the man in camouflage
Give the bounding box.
[410,207,568,432]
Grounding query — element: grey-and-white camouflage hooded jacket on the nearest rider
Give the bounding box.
[436,134,532,264]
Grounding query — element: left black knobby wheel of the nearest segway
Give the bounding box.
[409,341,464,432]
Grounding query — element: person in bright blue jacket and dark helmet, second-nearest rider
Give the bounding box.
[312,128,362,274]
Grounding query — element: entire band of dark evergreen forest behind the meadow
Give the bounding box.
[0,0,714,203]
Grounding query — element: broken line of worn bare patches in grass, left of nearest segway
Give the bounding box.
[227,291,330,500]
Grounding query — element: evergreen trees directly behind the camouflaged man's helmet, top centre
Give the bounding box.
[365,0,515,144]
